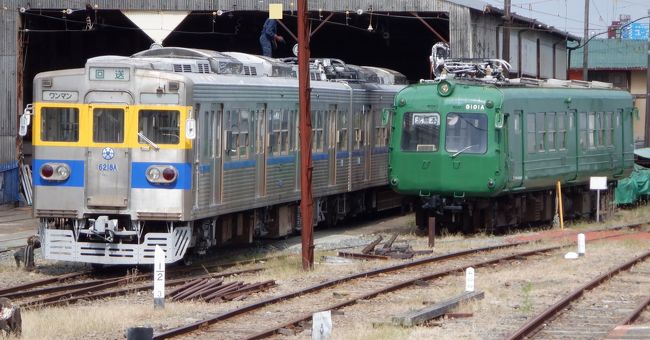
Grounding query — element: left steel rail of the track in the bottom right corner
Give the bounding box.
[508,247,650,340]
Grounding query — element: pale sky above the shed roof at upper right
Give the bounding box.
[483,0,650,38]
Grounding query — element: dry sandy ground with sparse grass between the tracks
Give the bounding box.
[0,206,650,339]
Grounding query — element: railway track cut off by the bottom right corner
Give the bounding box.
[509,251,650,339]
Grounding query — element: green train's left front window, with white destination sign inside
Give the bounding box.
[402,112,440,151]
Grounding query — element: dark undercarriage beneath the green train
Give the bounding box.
[415,183,614,233]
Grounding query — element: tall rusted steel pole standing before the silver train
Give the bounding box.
[298,0,314,270]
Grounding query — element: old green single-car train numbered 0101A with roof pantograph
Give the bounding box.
[388,77,635,232]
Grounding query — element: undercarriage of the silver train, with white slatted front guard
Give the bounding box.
[40,188,402,264]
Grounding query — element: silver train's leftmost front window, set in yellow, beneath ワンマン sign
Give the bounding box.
[41,107,79,142]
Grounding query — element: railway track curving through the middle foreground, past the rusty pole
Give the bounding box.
[155,226,644,339]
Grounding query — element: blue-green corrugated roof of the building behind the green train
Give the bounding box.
[570,39,648,70]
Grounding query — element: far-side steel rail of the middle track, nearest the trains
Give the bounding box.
[153,222,647,339]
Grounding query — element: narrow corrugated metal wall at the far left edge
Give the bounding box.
[0,7,18,204]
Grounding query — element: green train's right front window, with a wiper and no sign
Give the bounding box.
[445,113,487,153]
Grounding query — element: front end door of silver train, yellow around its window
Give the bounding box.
[86,105,131,208]
